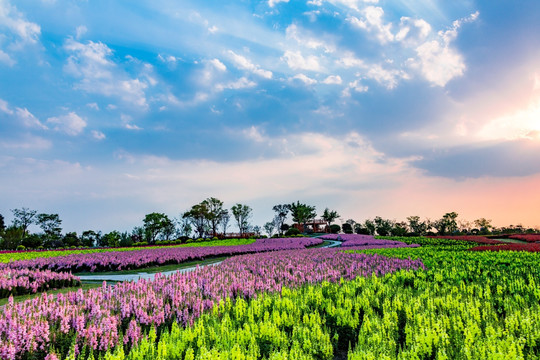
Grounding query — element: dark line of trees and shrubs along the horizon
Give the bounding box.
[0,202,539,250]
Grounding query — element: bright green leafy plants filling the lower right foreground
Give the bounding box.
[95,248,540,360]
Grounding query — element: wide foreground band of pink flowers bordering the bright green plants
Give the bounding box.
[0,249,424,359]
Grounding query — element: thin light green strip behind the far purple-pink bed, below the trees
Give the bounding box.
[0,239,255,263]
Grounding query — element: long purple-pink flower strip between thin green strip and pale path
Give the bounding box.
[0,238,322,272]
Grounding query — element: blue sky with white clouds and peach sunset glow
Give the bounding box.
[0,0,540,232]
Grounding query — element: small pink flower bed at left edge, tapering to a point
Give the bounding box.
[0,268,81,298]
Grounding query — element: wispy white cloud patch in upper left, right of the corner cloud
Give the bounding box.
[64,39,155,109]
